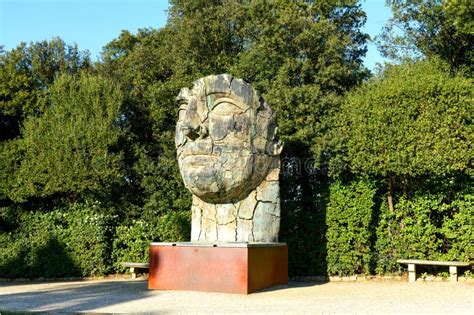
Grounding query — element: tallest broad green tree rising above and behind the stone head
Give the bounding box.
[161,0,368,153]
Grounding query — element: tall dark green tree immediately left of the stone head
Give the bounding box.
[98,28,192,222]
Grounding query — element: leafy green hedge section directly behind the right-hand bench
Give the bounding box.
[376,194,474,273]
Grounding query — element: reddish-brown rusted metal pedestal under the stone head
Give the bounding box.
[148,243,288,294]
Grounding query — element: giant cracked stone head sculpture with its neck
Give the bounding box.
[175,74,282,242]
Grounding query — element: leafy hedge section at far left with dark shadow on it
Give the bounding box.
[0,203,116,277]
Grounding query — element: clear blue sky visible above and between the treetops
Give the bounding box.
[0,0,390,69]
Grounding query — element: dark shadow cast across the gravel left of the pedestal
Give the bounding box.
[0,281,150,314]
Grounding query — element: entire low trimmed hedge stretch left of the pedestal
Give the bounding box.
[0,203,190,278]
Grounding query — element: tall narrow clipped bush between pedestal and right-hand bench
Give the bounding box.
[326,180,375,275]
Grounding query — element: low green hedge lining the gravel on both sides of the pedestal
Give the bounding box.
[0,191,468,278]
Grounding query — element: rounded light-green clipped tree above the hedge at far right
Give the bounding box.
[334,59,474,210]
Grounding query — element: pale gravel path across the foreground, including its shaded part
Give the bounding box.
[0,280,474,314]
